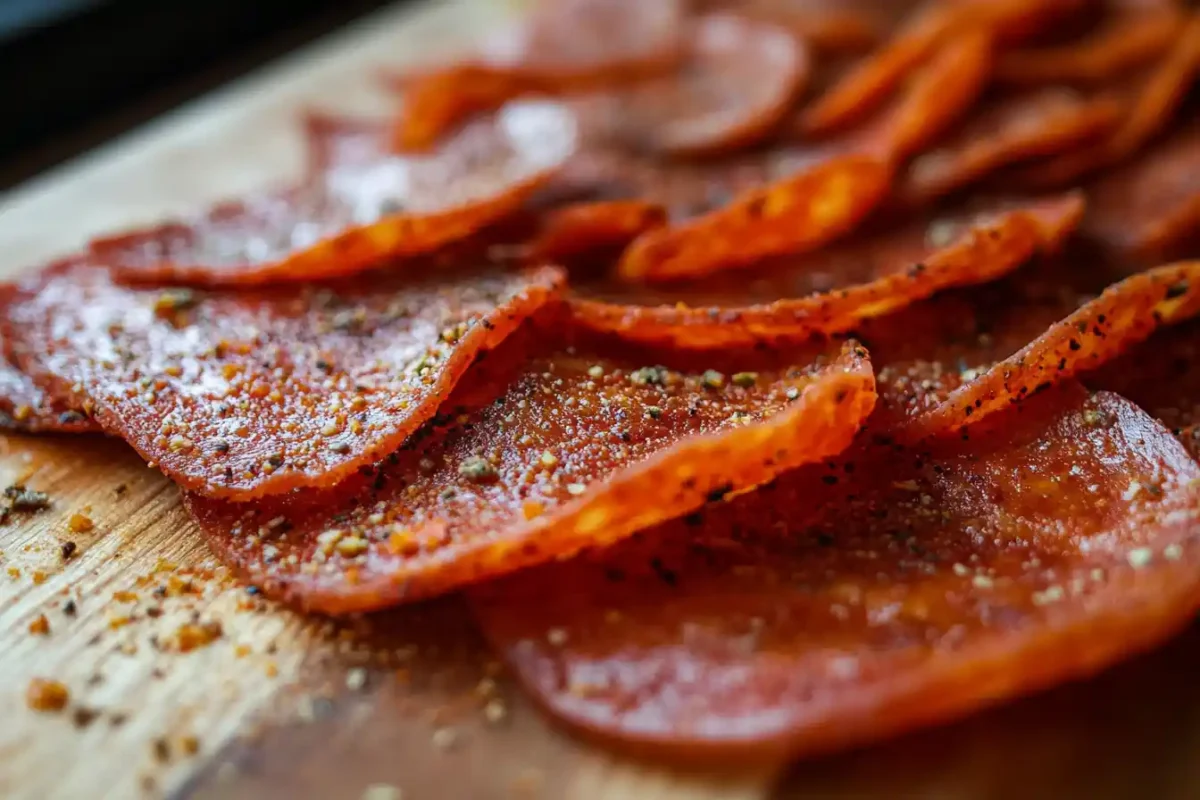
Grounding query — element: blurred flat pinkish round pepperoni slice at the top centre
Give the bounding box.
[574,14,809,157]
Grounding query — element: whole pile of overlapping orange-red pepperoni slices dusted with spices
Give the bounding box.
[0,0,1200,758]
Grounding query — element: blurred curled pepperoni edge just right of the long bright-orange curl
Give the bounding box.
[896,86,1122,205]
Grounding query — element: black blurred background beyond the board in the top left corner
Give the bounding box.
[0,0,396,191]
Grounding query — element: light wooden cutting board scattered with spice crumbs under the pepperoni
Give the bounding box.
[7,0,1200,800]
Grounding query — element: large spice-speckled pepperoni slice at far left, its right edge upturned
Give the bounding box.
[5,264,562,499]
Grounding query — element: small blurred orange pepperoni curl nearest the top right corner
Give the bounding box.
[996,8,1184,86]
